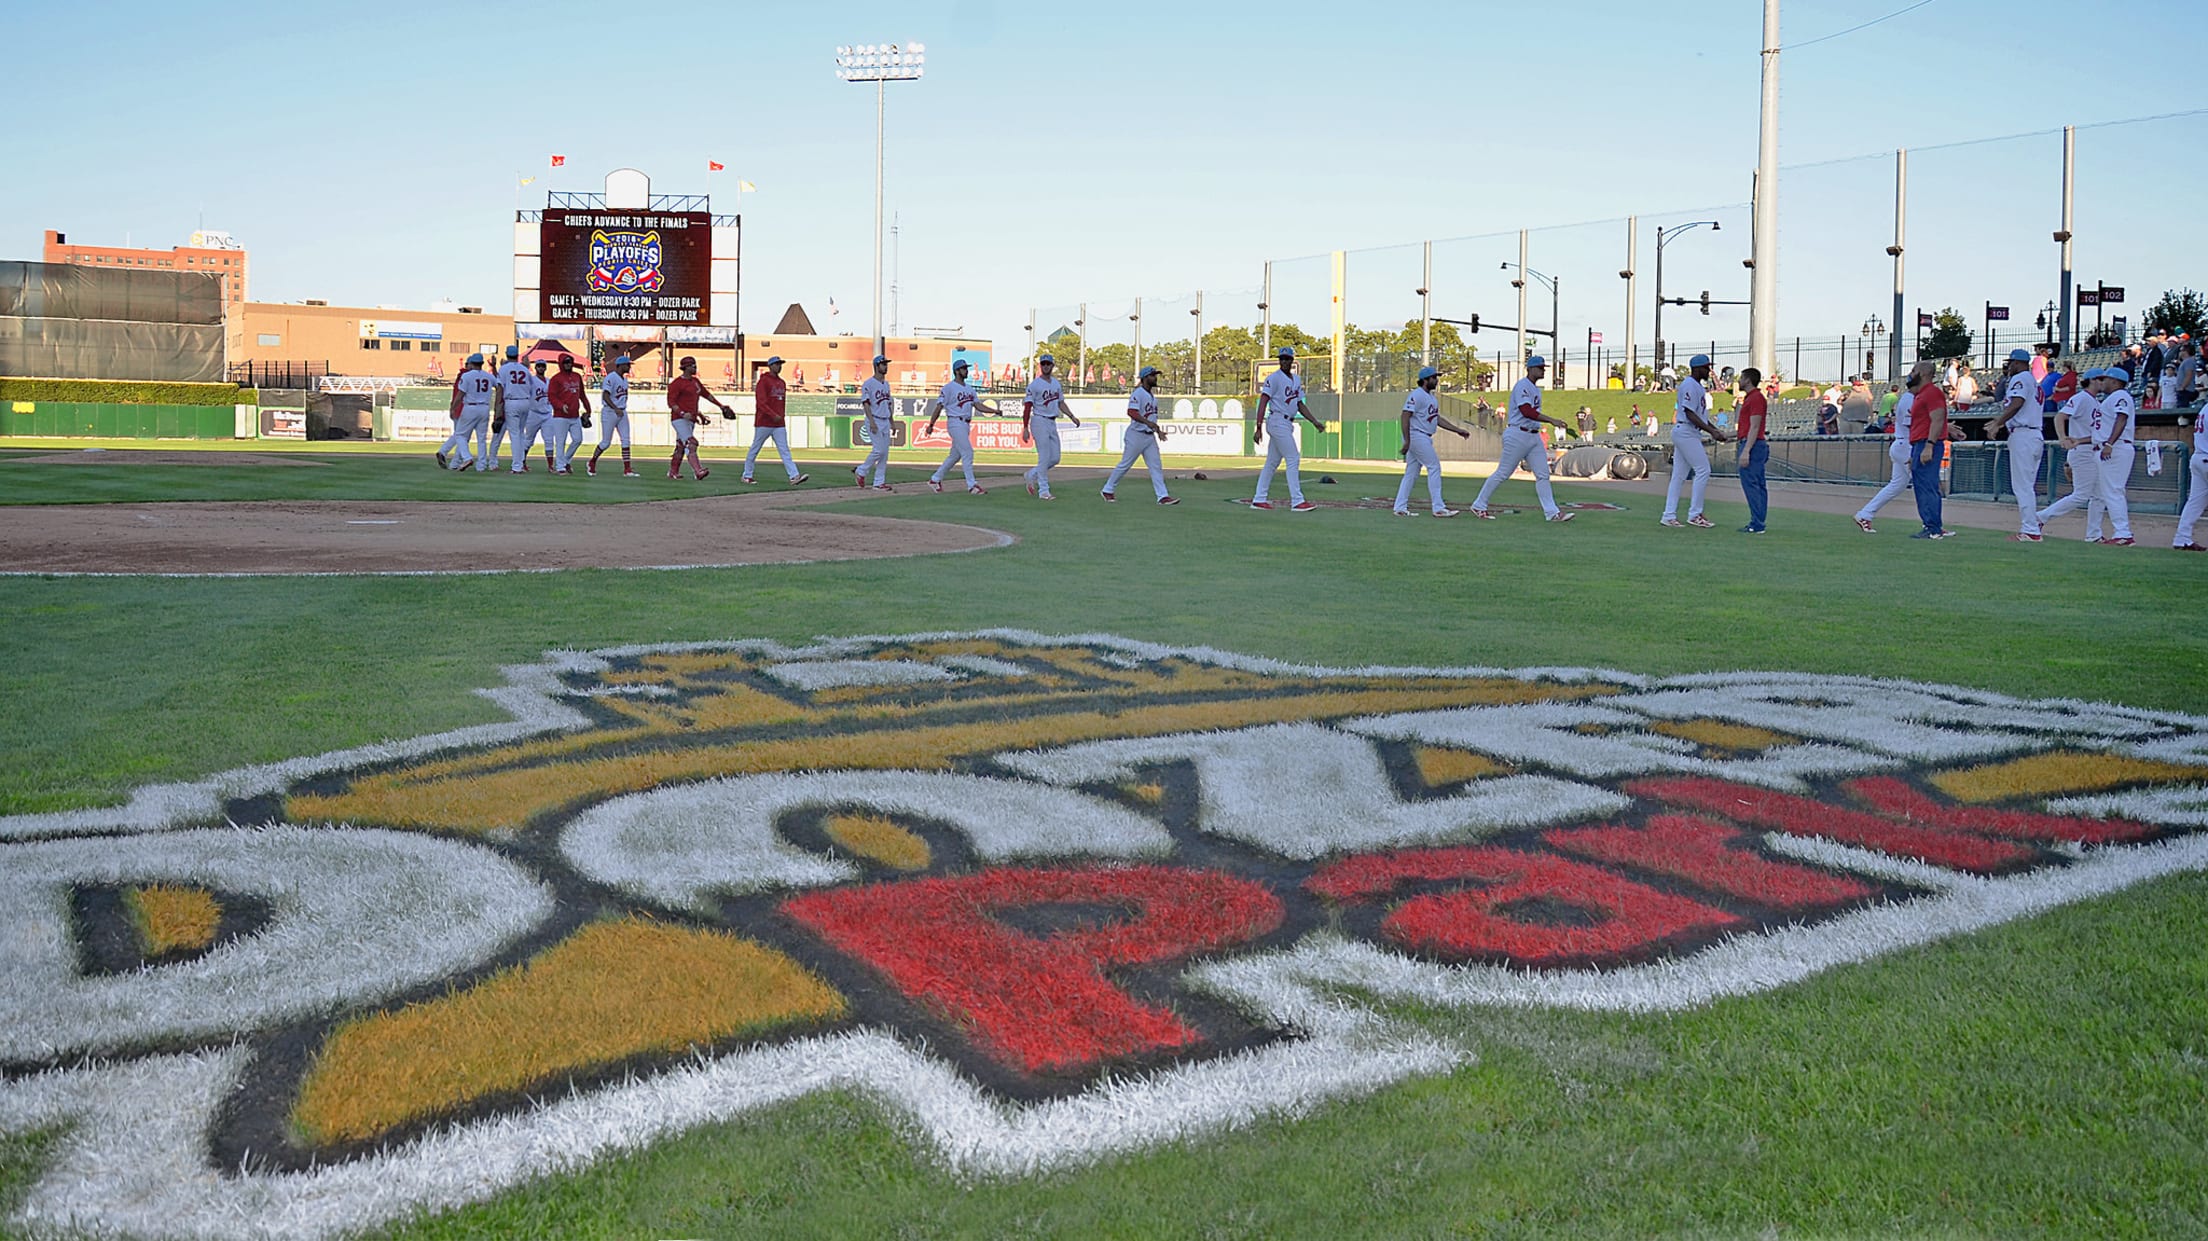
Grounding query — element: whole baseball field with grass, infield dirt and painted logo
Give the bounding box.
[0,439,2208,1239]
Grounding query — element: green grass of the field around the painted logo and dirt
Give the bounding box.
[0,457,2208,1239]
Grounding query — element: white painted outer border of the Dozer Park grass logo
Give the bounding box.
[0,627,2208,1237]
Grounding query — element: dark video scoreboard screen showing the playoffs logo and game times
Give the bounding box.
[537,210,713,327]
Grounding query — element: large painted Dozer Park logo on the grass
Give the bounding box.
[0,632,2208,1237]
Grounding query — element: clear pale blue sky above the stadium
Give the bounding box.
[0,0,2208,362]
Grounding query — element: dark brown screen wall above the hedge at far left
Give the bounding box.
[0,263,225,384]
